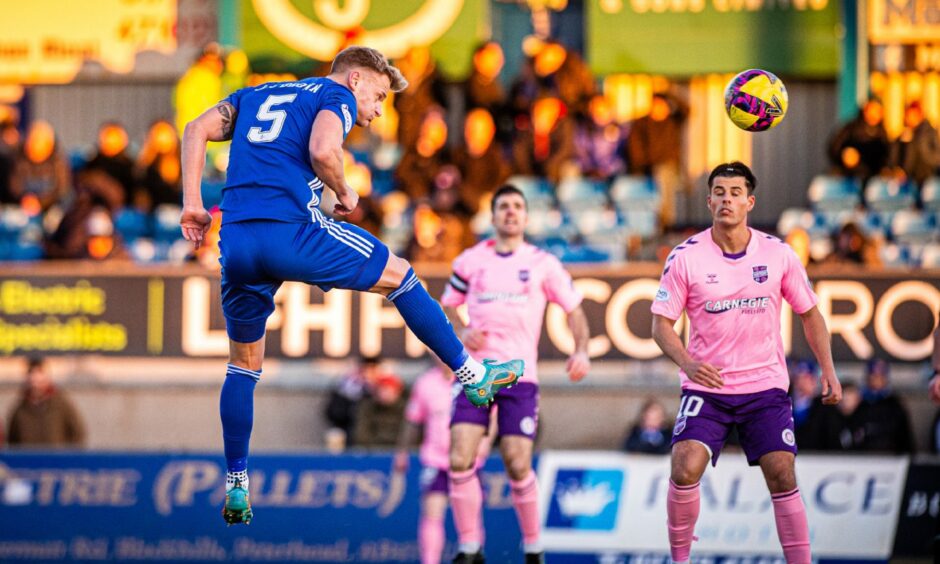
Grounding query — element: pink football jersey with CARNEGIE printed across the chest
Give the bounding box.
[651,229,817,394]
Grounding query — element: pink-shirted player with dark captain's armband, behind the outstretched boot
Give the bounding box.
[441,185,591,563]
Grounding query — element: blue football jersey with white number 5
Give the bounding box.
[222,77,356,223]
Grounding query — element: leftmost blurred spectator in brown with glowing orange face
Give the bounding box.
[10,120,72,212]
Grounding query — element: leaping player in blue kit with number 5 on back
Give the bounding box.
[180,46,524,525]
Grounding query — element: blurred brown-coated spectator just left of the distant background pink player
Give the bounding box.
[354,374,405,448]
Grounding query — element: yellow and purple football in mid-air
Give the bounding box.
[725,69,788,131]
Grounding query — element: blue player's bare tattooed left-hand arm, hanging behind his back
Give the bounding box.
[180,101,238,249]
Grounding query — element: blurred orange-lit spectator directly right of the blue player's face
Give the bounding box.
[395,46,446,153]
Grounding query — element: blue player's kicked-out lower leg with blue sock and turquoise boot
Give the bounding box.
[388,263,525,406]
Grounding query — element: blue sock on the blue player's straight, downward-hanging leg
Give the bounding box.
[219,364,261,472]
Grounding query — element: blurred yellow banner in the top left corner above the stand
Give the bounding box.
[0,0,176,84]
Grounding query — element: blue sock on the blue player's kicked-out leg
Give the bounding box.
[388,268,469,370]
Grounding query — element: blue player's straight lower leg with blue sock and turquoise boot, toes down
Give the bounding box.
[219,364,261,525]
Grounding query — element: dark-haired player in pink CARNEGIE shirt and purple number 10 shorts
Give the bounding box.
[652,162,842,564]
